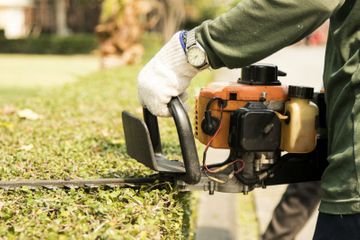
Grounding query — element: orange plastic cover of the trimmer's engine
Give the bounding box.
[195,82,287,149]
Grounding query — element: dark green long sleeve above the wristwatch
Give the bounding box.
[196,0,345,68]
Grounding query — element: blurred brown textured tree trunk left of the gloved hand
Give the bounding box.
[96,0,157,68]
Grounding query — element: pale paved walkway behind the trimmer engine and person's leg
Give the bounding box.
[197,47,324,240]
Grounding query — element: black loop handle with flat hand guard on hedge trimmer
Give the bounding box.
[122,97,201,184]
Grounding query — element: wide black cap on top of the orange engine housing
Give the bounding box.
[238,64,286,86]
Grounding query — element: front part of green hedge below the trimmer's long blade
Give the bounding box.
[0,189,191,239]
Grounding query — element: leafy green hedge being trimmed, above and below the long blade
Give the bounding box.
[0,34,209,239]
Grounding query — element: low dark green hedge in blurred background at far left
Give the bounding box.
[0,34,98,55]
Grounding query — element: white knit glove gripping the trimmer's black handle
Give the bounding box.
[138,32,200,117]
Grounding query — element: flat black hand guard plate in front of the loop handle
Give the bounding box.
[122,112,185,173]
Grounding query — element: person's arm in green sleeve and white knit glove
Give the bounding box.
[138,0,344,116]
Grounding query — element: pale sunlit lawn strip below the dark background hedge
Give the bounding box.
[0,54,99,88]
